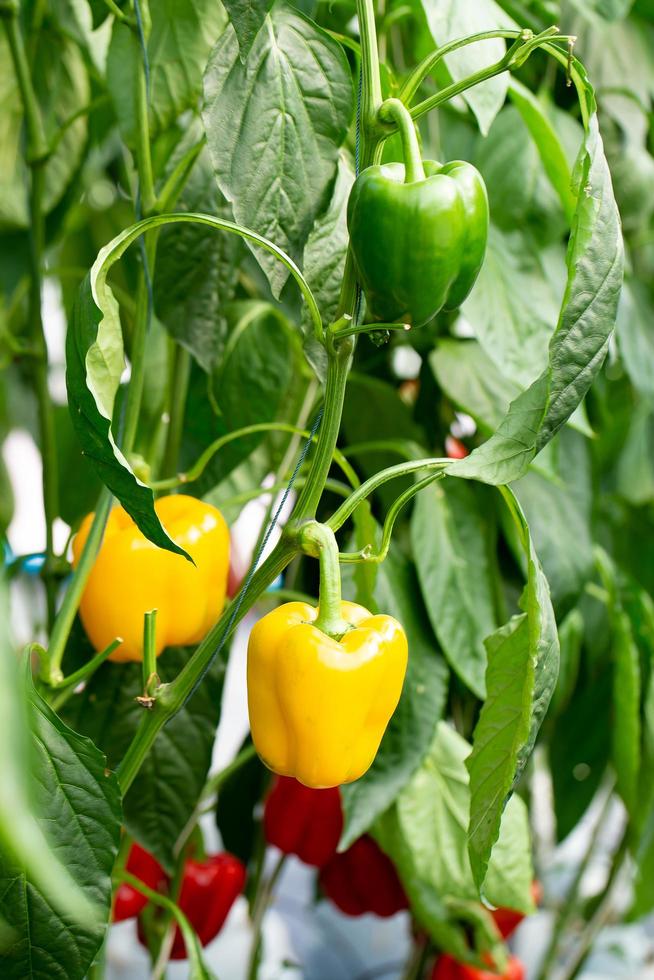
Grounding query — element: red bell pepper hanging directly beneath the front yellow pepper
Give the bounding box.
[263,776,343,868]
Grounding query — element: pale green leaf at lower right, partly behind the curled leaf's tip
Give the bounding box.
[374,722,533,944]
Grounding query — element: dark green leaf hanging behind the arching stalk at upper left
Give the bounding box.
[154,137,243,373]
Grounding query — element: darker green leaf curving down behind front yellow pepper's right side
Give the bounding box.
[339,551,448,850]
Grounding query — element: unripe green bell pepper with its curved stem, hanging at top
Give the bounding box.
[347,99,488,327]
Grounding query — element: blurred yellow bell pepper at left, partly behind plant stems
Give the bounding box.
[73,494,229,662]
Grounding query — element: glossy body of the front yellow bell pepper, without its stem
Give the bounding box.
[248,602,408,789]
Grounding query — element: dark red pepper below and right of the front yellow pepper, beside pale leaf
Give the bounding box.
[320,834,409,917]
